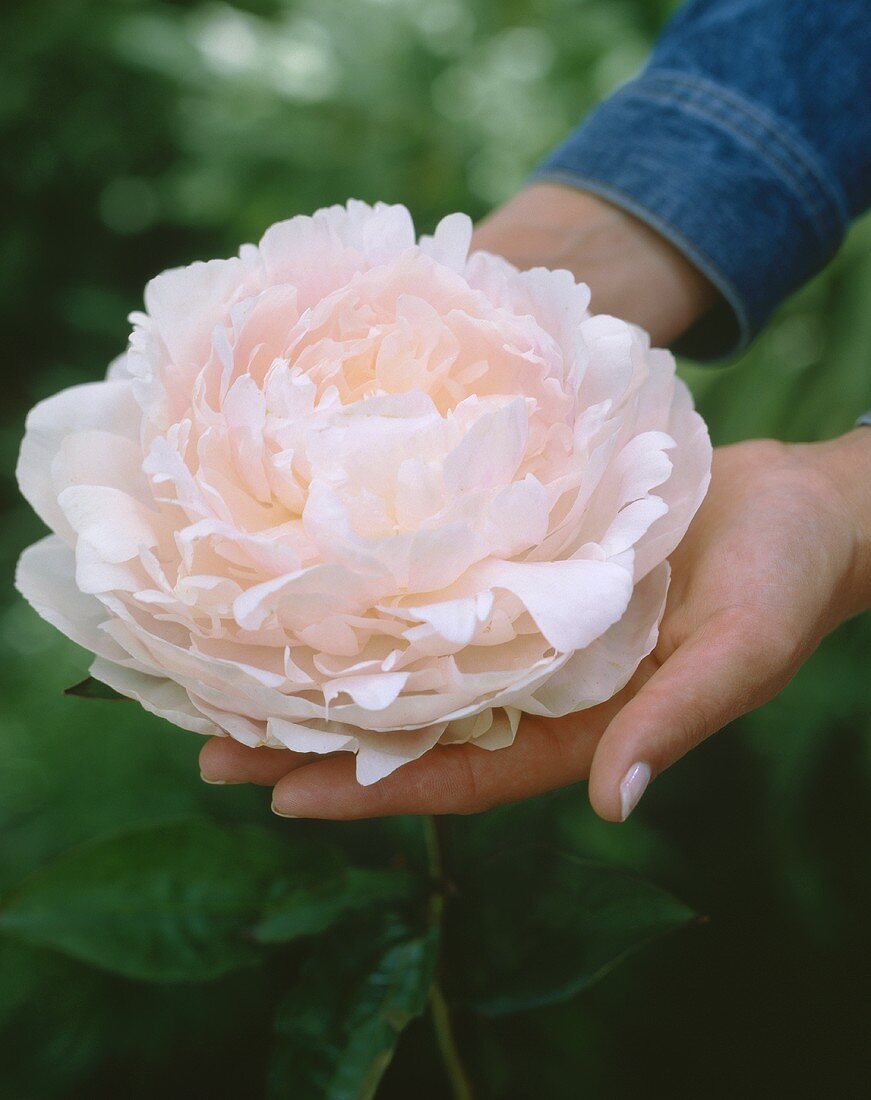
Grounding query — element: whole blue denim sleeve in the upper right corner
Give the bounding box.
[533,0,871,359]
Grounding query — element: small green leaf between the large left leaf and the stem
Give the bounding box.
[254,867,419,944]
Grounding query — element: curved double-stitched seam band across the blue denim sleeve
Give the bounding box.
[614,74,847,248]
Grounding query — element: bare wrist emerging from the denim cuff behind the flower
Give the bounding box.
[473,184,716,345]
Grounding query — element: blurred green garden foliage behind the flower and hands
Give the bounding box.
[0,0,871,1100]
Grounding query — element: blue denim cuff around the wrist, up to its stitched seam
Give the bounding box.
[531,69,848,360]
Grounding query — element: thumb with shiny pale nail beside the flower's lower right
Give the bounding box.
[589,609,791,822]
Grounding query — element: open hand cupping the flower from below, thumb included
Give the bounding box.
[200,428,871,821]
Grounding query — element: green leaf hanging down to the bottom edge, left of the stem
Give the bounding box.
[269,921,439,1100]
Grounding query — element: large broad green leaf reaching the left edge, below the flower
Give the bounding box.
[0,821,288,981]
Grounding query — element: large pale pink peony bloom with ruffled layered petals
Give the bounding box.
[18,201,710,783]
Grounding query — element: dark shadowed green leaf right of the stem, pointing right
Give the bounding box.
[448,846,695,1015]
